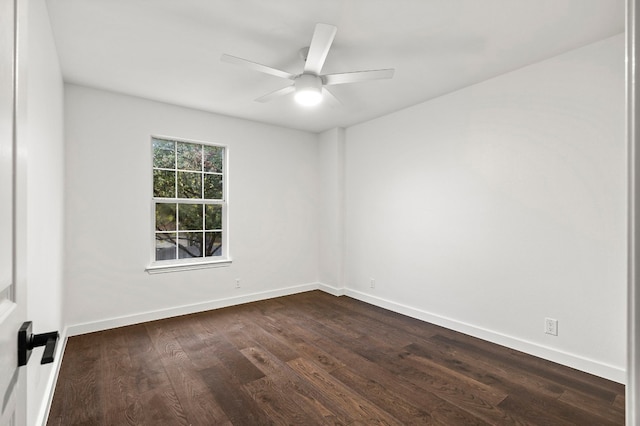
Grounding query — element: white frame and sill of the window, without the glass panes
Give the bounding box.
[146,135,232,274]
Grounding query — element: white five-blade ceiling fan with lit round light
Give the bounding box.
[220,23,394,106]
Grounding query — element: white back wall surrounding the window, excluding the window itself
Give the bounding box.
[65,85,318,333]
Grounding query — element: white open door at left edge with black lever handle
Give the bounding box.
[0,0,26,426]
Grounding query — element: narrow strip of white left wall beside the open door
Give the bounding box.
[26,0,64,425]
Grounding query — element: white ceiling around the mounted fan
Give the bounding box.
[48,0,624,132]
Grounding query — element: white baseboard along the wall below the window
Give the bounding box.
[67,283,319,337]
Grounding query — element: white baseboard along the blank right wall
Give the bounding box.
[342,288,627,384]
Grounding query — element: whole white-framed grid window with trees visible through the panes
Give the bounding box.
[148,137,228,270]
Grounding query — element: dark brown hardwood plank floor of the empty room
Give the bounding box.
[48,291,624,426]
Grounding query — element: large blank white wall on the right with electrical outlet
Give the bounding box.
[346,35,627,381]
